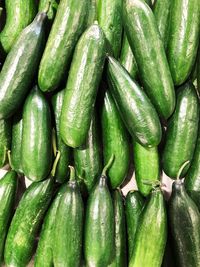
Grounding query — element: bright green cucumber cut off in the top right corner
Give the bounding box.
[167,0,200,85]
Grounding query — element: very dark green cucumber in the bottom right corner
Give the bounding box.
[169,181,200,267]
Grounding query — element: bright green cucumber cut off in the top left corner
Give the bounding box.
[0,0,36,53]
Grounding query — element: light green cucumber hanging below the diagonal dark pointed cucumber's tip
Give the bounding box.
[133,141,160,196]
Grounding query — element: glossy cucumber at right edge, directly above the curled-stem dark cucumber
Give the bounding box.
[162,82,199,178]
